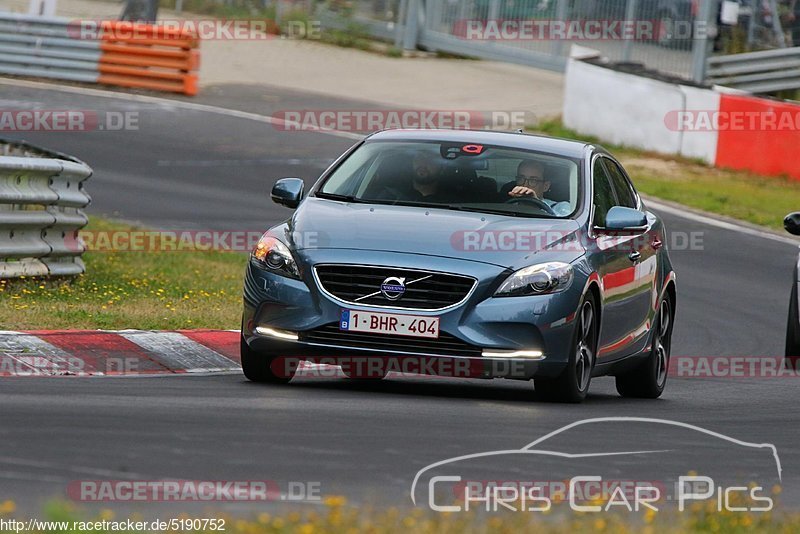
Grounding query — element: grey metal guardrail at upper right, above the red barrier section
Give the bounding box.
[708,47,800,94]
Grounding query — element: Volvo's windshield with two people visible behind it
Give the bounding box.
[317,141,580,218]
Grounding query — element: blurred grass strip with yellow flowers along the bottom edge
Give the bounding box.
[0,496,800,534]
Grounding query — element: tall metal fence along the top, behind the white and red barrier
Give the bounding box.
[318,0,786,86]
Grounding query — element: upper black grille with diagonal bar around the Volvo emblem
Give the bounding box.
[314,265,476,310]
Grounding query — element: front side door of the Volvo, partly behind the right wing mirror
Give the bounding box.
[589,155,639,362]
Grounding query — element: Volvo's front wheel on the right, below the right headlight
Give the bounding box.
[533,293,598,403]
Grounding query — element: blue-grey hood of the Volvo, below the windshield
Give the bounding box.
[274,197,585,268]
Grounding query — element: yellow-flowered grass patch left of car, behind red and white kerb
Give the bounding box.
[0,218,247,330]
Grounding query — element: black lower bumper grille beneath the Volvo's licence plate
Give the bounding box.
[299,323,482,358]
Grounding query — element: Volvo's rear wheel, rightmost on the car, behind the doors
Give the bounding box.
[617,296,673,399]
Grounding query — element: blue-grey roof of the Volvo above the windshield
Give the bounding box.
[367,129,599,158]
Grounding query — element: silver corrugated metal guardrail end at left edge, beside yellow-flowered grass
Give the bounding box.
[0,139,92,278]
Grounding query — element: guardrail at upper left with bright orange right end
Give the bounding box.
[0,13,199,95]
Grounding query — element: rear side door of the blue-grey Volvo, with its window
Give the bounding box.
[600,156,658,356]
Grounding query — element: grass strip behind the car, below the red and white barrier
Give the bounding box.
[536,121,800,229]
